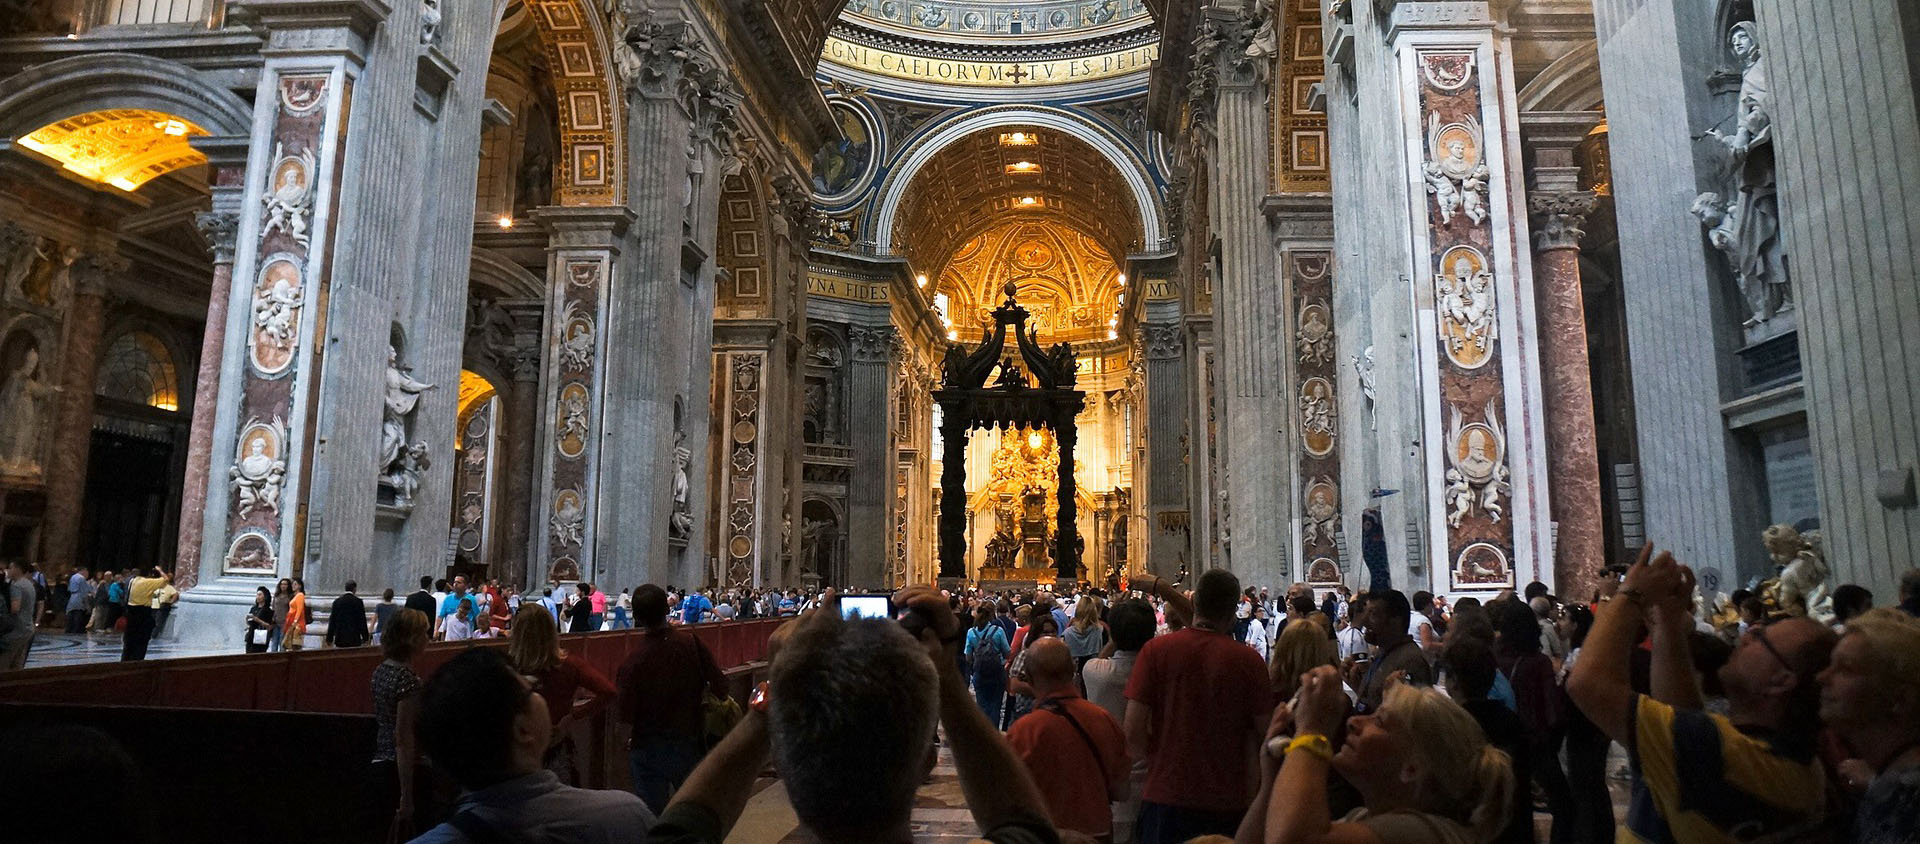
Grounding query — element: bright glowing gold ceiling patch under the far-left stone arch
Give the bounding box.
[19,109,207,190]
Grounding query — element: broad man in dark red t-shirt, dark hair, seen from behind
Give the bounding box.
[1127,568,1273,844]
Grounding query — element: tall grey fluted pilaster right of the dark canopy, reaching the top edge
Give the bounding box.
[1190,4,1290,585]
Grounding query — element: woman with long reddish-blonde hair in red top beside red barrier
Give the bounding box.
[507,604,616,785]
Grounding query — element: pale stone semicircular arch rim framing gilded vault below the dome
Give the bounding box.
[872,106,1167,255]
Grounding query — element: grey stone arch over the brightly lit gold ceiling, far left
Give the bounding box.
[0,52,253,138]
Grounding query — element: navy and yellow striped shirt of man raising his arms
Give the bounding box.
[1615,694,1826,844]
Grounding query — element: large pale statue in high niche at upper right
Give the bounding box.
[1692,21,1793,328]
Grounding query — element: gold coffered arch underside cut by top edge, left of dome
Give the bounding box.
[510,0,626,205]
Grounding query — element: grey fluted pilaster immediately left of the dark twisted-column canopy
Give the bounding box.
[835,326,894,589]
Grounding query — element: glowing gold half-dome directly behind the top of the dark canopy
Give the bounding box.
[935,219,1125,345]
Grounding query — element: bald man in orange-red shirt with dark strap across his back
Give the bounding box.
[1006,637,1133,840]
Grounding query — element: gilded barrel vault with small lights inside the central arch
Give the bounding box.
[893,127,1140,269]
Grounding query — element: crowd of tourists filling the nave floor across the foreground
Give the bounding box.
[8,549,1920,844]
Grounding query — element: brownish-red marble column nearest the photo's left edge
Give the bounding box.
[40,253,127,579]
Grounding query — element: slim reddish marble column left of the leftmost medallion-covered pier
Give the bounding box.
[173,211,240,589]
